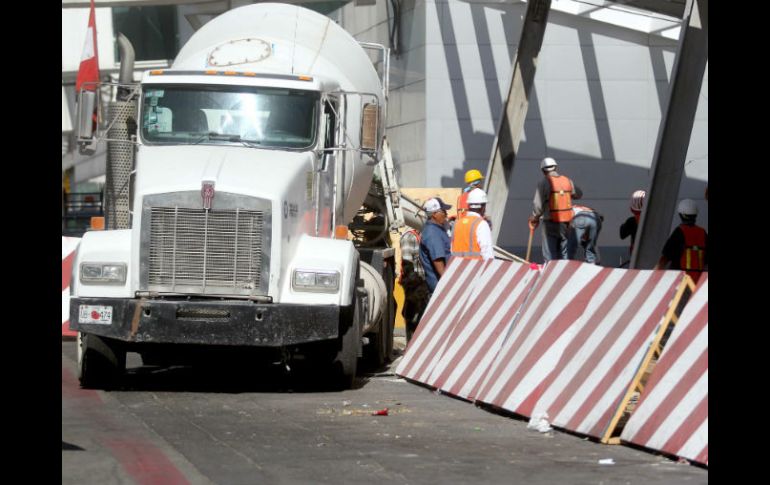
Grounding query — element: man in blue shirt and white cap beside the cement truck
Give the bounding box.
[420,197,452,299]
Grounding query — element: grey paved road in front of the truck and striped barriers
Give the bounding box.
[62,342,708,485]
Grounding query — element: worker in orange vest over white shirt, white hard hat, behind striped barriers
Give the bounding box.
[452,188,495,259]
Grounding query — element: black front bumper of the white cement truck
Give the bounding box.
[70,297,340,347]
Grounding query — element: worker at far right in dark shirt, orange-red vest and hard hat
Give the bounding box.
[655,199,708,283]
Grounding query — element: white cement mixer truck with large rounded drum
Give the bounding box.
[70,3,395,388]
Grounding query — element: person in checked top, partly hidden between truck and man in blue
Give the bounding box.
[399,229,430,343]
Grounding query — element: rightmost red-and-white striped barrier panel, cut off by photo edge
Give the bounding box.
[620,273,709,465]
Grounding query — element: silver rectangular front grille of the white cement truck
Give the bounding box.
[146,202,265,295]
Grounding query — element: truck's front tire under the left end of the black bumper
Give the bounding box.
[77,332,126,389]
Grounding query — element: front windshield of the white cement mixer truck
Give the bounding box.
[142,85,320,149]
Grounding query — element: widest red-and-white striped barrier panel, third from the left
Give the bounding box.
[477,261,684,437]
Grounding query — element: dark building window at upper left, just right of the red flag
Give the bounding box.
[112,5,179,61]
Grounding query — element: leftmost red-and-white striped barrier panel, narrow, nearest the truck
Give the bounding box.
[396,258,488,383]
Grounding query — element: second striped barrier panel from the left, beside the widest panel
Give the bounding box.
[426,260,540,399]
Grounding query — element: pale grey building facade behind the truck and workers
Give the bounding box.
[62,0,708,266]
